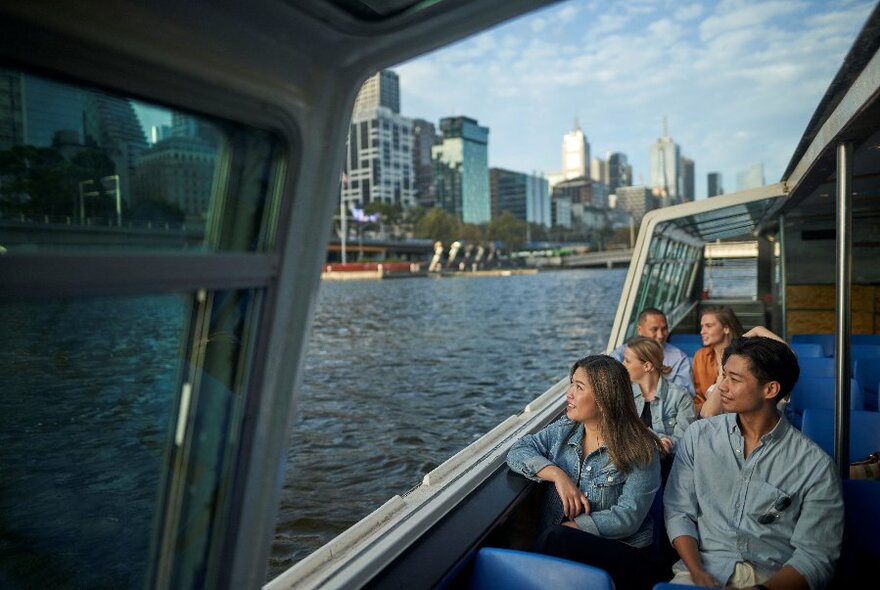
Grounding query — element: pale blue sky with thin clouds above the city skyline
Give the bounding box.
[392,0,873,199]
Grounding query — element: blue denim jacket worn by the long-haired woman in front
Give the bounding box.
[507,418,660,547]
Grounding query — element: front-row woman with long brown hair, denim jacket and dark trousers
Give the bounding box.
[507,355,660,588]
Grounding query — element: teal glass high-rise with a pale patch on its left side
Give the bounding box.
[431,117,492,223]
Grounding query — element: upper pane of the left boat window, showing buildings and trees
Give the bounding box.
[0,68,280,252]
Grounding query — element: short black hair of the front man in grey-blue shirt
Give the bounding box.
[721,336,801,401]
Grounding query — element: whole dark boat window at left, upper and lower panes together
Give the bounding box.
[0,69,287,588]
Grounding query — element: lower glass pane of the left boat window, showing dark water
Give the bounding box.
[0,295,191,588]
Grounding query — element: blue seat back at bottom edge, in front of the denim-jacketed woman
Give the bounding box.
[470,547,614,590]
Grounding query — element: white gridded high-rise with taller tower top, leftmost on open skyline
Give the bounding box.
[342,70,416,208]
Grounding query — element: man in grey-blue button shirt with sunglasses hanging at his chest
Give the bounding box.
[664,337,843,590]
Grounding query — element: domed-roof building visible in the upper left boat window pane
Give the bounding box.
[134,137,217,222]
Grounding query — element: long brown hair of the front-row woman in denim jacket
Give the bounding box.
[570,354,660,473]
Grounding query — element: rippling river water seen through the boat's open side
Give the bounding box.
[269,269,626,578]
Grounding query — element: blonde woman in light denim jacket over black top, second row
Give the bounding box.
[623,336,696,482]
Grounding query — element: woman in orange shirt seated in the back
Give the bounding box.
[693,305,743,414]
